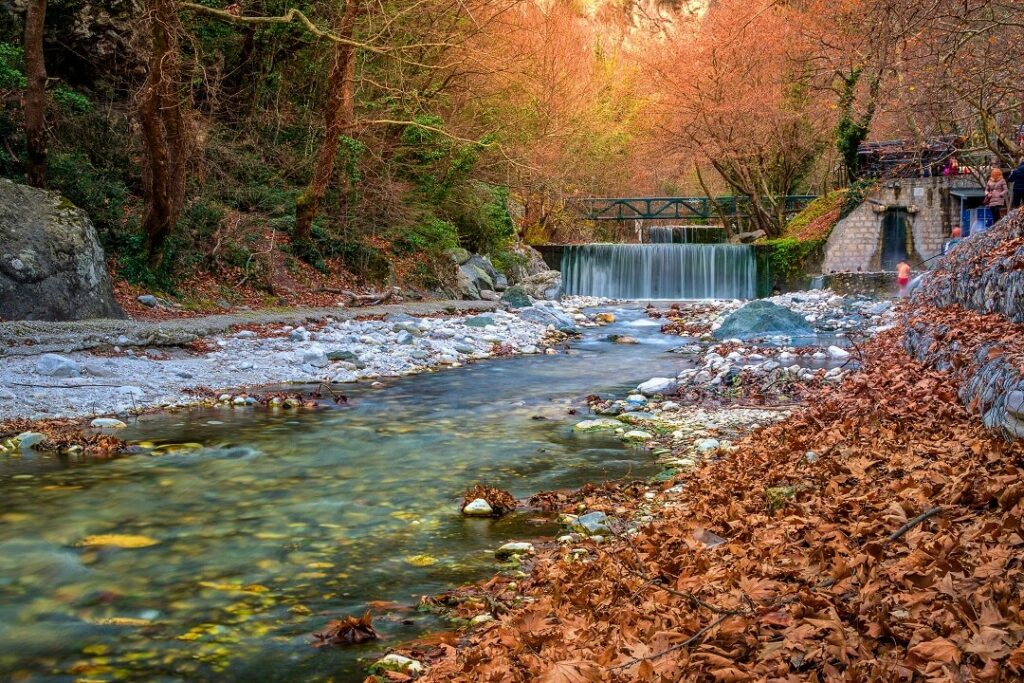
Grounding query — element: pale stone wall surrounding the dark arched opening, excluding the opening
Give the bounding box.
[822,176,978,273]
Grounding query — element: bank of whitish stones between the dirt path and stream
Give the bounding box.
[0,301,591,444]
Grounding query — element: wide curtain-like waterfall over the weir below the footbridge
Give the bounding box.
[562,244,757,299]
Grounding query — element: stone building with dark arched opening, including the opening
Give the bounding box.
[821,175,985,273]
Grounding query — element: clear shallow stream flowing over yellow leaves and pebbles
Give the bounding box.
[0,309,685,682]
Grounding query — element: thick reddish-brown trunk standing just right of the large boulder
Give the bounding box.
[138,0,188,269]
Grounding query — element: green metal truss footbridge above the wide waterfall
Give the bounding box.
[567,195,817,221]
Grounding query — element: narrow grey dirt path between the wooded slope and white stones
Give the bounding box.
[0,300,500,355]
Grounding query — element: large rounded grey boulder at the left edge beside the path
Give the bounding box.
[0,179,124,321]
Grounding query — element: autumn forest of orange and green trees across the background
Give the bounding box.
[0,0,1024,288]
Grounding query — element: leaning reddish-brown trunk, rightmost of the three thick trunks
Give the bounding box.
[295,0,361,242]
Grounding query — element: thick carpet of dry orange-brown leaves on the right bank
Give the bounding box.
[415,323,1024,683]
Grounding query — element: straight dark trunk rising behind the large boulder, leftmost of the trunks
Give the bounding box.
[25,0,46,187]
